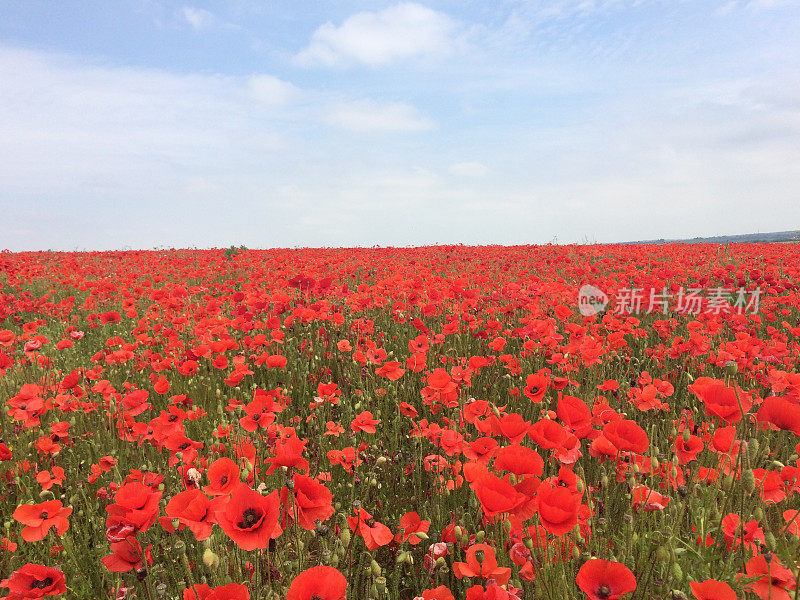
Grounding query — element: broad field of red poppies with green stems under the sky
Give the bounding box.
[0,244,800,600]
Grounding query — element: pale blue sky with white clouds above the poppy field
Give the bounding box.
[0,0,800,250]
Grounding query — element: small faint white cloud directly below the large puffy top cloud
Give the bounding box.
[326,101,436,133]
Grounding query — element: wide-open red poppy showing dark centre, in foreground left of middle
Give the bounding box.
[217,482,282,550]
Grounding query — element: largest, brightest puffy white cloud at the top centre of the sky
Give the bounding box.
[295,2,457,66]
